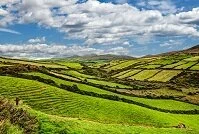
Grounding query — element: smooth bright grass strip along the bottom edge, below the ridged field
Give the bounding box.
[24,106,193,134]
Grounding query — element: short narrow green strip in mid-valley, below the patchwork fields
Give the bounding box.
[87,79,132,88]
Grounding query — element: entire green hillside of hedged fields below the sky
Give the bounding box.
[0,46,199,134]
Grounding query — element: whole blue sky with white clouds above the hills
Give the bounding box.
[0,0,199,58]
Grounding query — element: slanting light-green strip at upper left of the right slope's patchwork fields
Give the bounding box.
[108,60,139,71]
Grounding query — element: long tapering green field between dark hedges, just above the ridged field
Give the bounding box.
[19,73,199,110]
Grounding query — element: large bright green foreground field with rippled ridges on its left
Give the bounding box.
[0,76,199,132]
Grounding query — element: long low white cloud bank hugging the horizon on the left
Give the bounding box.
[0,43,129,58]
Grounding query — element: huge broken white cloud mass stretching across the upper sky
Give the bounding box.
[0,0,199,45]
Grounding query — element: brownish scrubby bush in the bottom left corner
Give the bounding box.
[0,99,38,134]
